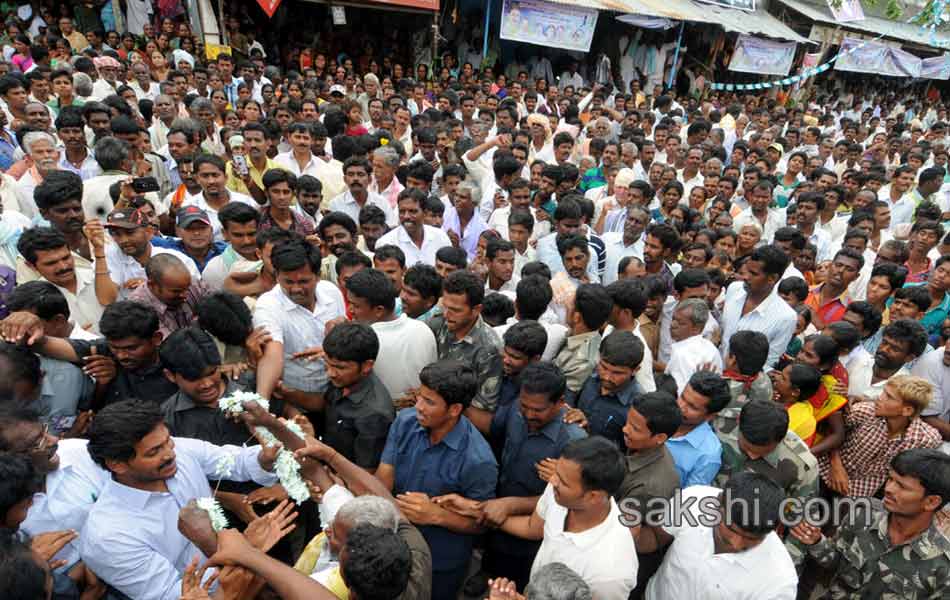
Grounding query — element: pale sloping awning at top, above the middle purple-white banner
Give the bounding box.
[617,0,811,43]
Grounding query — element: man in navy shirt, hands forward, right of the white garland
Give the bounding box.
[376,360,498,600]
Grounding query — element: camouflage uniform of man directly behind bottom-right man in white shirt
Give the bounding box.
[713,419,818,573]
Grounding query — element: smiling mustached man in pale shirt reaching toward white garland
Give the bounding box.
[79,400,279,600]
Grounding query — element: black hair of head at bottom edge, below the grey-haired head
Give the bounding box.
[341,523,412,600]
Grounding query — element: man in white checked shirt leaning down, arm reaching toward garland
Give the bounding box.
[254,240,346,398]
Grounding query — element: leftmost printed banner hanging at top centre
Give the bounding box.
[501,0,597,52]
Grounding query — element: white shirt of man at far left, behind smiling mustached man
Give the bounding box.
[20,439,110,570]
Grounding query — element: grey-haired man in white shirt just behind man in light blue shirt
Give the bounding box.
[666,298,722,394]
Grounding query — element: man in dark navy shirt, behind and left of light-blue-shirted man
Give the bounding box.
[577,331,644,448]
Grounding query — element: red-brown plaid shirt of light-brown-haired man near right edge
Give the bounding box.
[818,402,942,497]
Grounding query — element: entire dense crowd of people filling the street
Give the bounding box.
[0,1,950,600]
